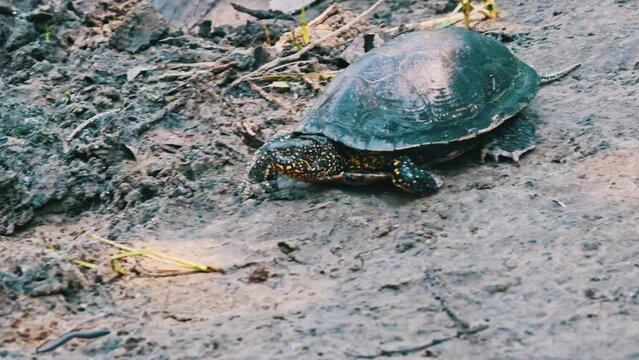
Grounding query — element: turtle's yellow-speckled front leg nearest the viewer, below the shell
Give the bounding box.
[392,156,444,195]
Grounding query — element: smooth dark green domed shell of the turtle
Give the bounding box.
[297,28,539,151]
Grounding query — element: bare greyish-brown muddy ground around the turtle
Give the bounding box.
[0,0,639,359]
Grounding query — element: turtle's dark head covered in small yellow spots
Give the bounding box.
[249,133,345,182]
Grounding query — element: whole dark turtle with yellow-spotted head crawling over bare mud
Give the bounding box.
[248,27,579,196]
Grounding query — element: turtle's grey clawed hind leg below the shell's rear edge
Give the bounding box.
[481,116,536,165]
